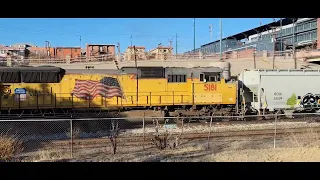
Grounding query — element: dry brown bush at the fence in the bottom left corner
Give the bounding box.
[0,134,23,161]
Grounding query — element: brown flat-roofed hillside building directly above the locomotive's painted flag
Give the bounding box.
[86,44,116,57]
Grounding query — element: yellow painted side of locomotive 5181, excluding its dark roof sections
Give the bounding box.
[0,70,237,109]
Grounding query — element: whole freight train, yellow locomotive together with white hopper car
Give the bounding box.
[0,63,320,119]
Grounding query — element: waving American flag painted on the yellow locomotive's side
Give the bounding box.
[71,77,124,100]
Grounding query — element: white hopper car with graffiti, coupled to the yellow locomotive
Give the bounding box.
[238,70,320,114]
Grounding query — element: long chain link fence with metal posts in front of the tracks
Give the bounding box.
[0,113,320,162]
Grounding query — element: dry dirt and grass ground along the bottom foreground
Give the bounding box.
[23,129,320,162]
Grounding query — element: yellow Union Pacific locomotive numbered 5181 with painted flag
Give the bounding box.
[0,67,237,115]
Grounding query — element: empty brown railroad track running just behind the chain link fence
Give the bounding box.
[37,127,320,148]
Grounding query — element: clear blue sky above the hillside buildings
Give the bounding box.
[0,18,279,53]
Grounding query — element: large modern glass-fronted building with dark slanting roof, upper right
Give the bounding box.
[186,18,320,54]
